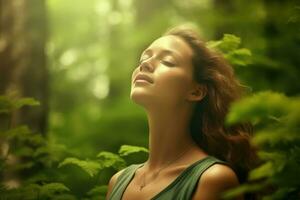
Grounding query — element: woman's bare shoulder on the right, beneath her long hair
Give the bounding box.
[193,164,243,200]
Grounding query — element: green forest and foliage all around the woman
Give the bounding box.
[0,0,300,199]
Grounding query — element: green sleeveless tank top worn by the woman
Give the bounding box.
[108,156,227,200]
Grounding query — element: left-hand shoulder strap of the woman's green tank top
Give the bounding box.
[108,164,143,200]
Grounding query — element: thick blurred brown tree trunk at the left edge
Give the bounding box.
[0,0,48,134]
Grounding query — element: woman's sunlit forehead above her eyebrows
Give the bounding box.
[146,35,193,60]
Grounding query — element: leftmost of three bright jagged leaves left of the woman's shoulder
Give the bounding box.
[58,157,101,177]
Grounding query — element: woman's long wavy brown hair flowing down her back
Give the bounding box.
[164,27,257,183]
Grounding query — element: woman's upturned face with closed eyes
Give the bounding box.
[130,35,195,107]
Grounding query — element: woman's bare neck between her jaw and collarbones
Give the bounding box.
[147,104,197,169]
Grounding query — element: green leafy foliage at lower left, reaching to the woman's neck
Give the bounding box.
[0,97,148,200]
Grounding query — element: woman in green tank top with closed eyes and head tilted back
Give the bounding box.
[107,27,254,200]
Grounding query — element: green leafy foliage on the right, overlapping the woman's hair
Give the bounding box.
[227,91,300,199]
